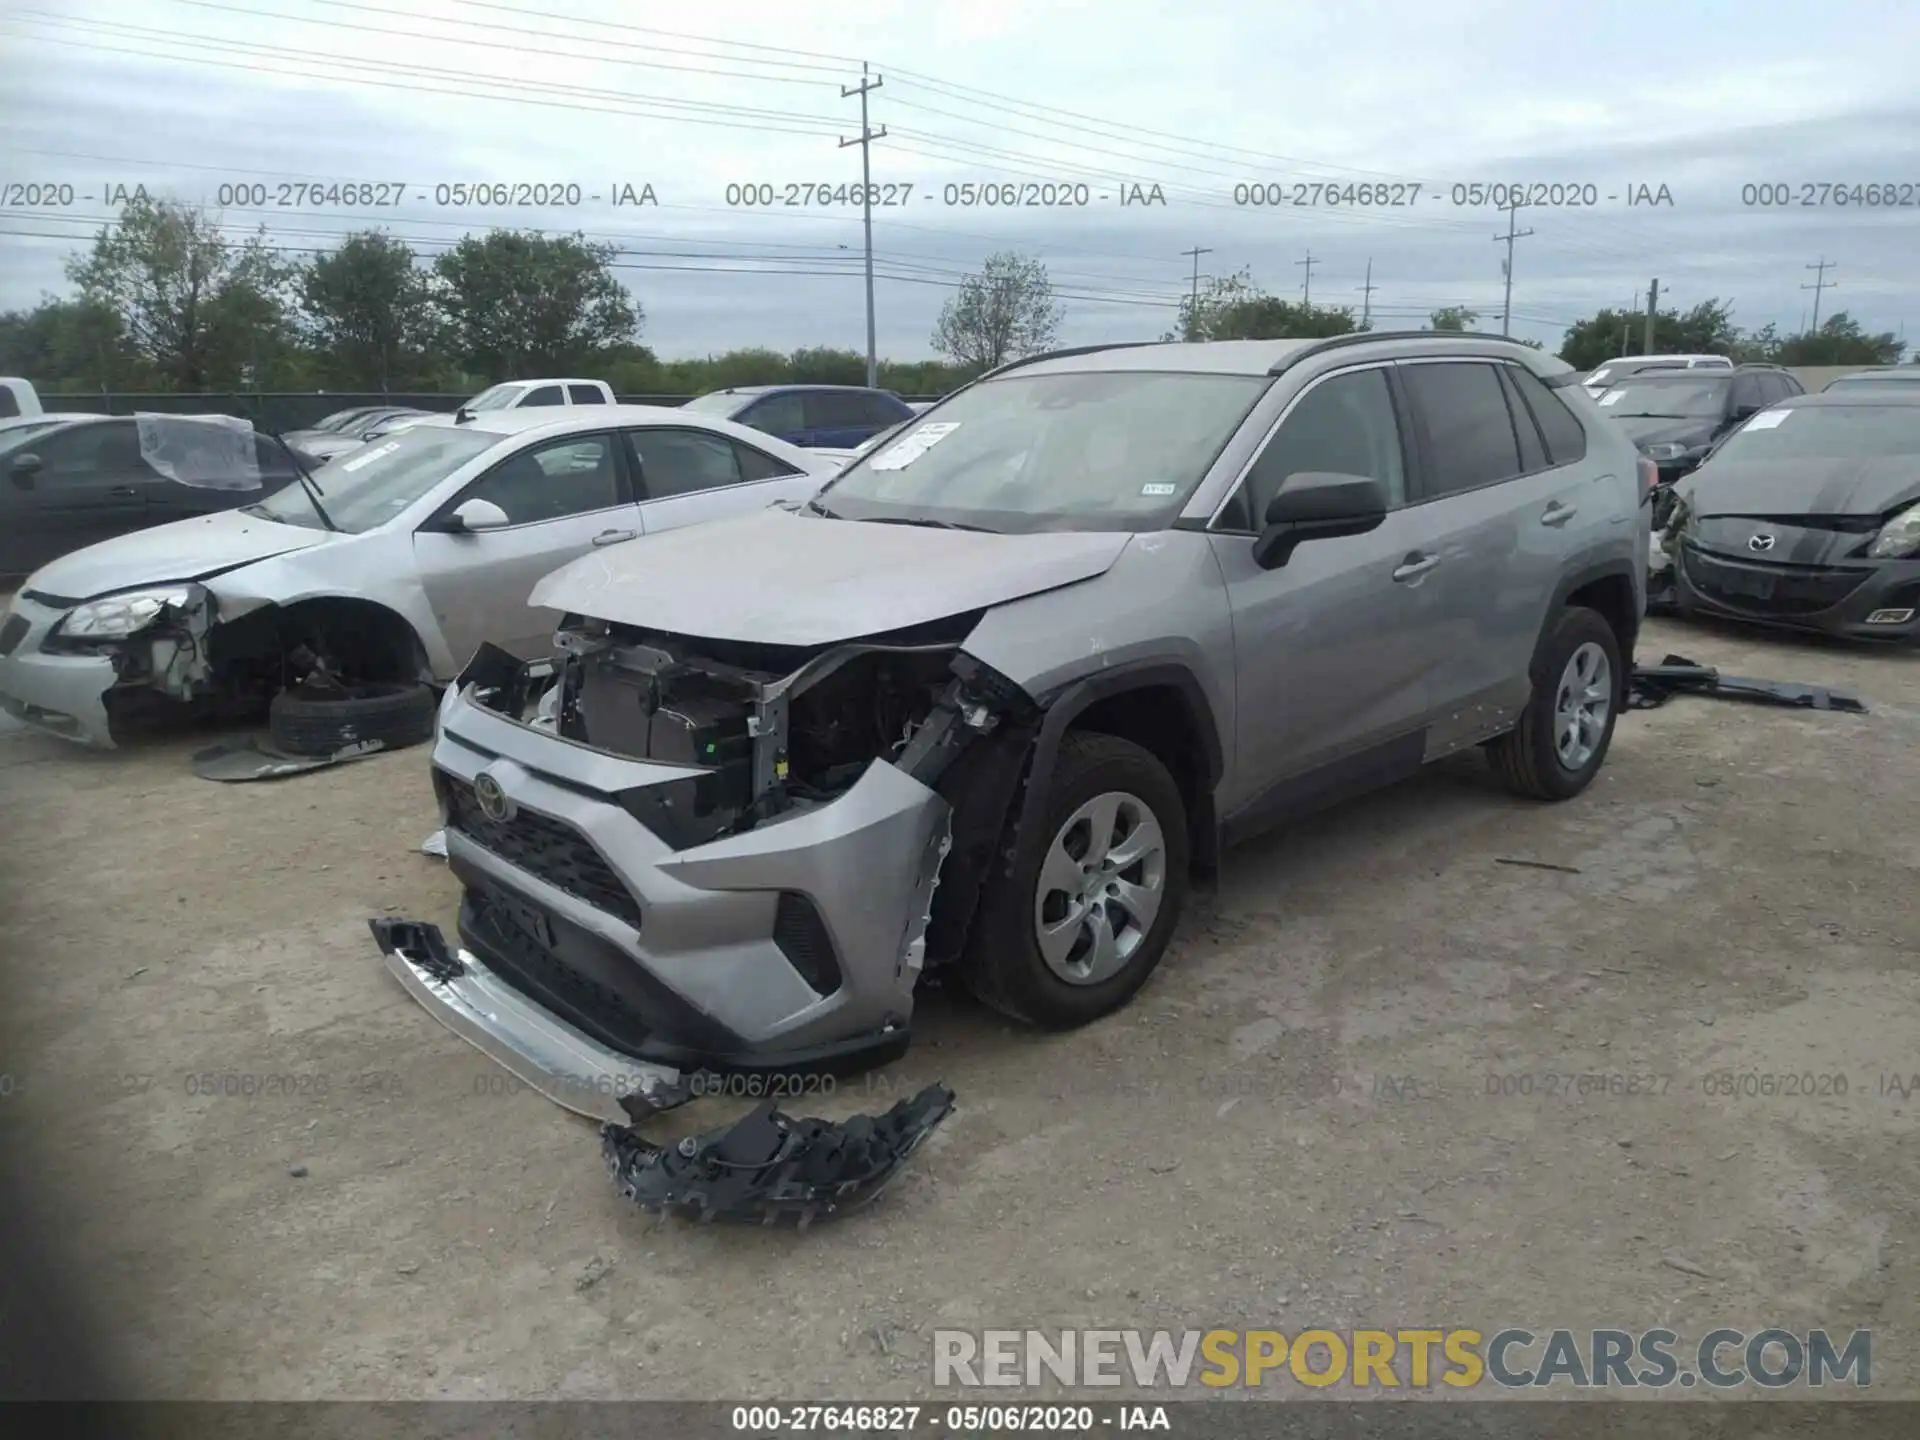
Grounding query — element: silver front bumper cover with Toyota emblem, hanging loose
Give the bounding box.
[396,685,950,1108]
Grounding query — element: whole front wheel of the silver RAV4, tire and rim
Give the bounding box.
[962,732,1188,1029]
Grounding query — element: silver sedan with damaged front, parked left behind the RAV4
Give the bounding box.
[0,405,837,745]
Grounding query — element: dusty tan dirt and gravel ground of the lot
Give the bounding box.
[0,622,1920,1400]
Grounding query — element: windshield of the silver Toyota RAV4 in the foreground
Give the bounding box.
[818,371,1273,532]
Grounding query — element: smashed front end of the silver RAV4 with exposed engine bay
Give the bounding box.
[384,616,1039,1119]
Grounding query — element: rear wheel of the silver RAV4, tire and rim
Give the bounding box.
[1488,605,1626,801]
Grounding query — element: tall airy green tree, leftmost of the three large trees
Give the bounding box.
[67,198,294,390]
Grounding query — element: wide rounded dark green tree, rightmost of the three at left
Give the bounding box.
[434,230,645,380]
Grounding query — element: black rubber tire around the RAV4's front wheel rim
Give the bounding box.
[960,732,1188,1029]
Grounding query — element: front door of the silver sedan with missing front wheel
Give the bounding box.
[413,432,641,660]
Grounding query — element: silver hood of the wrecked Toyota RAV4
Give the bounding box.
[528,509,1133,645]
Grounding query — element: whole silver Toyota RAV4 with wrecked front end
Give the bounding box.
[382,334,1651,1123]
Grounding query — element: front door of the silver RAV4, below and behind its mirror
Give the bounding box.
[1212,365,1440,828]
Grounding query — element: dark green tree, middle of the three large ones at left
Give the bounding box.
[300,230,438,394]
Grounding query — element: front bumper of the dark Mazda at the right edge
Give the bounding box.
[1674,540,1920,643]
